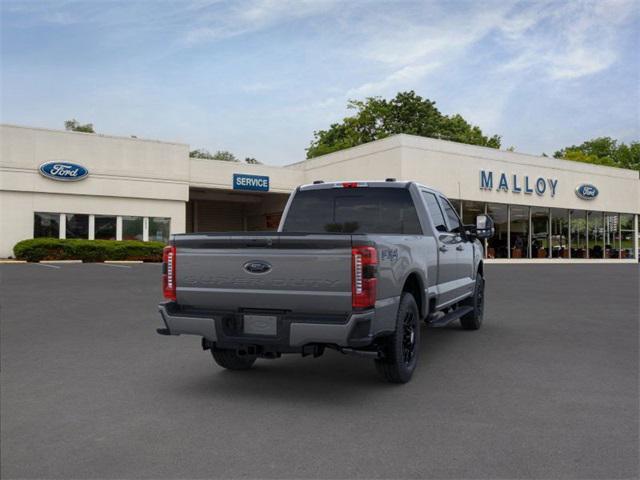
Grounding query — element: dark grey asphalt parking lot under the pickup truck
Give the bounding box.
[0,264,640,479]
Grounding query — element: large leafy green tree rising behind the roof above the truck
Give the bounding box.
[307,90,500,158]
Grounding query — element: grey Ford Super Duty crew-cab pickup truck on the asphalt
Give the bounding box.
[158,179,493,383]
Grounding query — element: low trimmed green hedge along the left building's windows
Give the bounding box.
[13,238,164,262]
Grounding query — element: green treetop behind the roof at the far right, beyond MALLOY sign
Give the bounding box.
[553,137,640,171]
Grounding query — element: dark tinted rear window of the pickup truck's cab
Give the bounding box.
[282,187,422,235]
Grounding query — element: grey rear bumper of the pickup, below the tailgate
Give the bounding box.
[158,302,376,350]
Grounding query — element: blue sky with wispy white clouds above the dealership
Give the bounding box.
[0,0,640,165]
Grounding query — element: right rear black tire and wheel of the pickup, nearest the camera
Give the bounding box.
[375,293,422,383]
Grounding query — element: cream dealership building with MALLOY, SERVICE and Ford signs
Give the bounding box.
[0,125,640,262]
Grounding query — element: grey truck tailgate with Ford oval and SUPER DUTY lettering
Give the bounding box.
[174,233,351,314]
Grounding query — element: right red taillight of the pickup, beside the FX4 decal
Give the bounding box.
[351,247,378,308]
